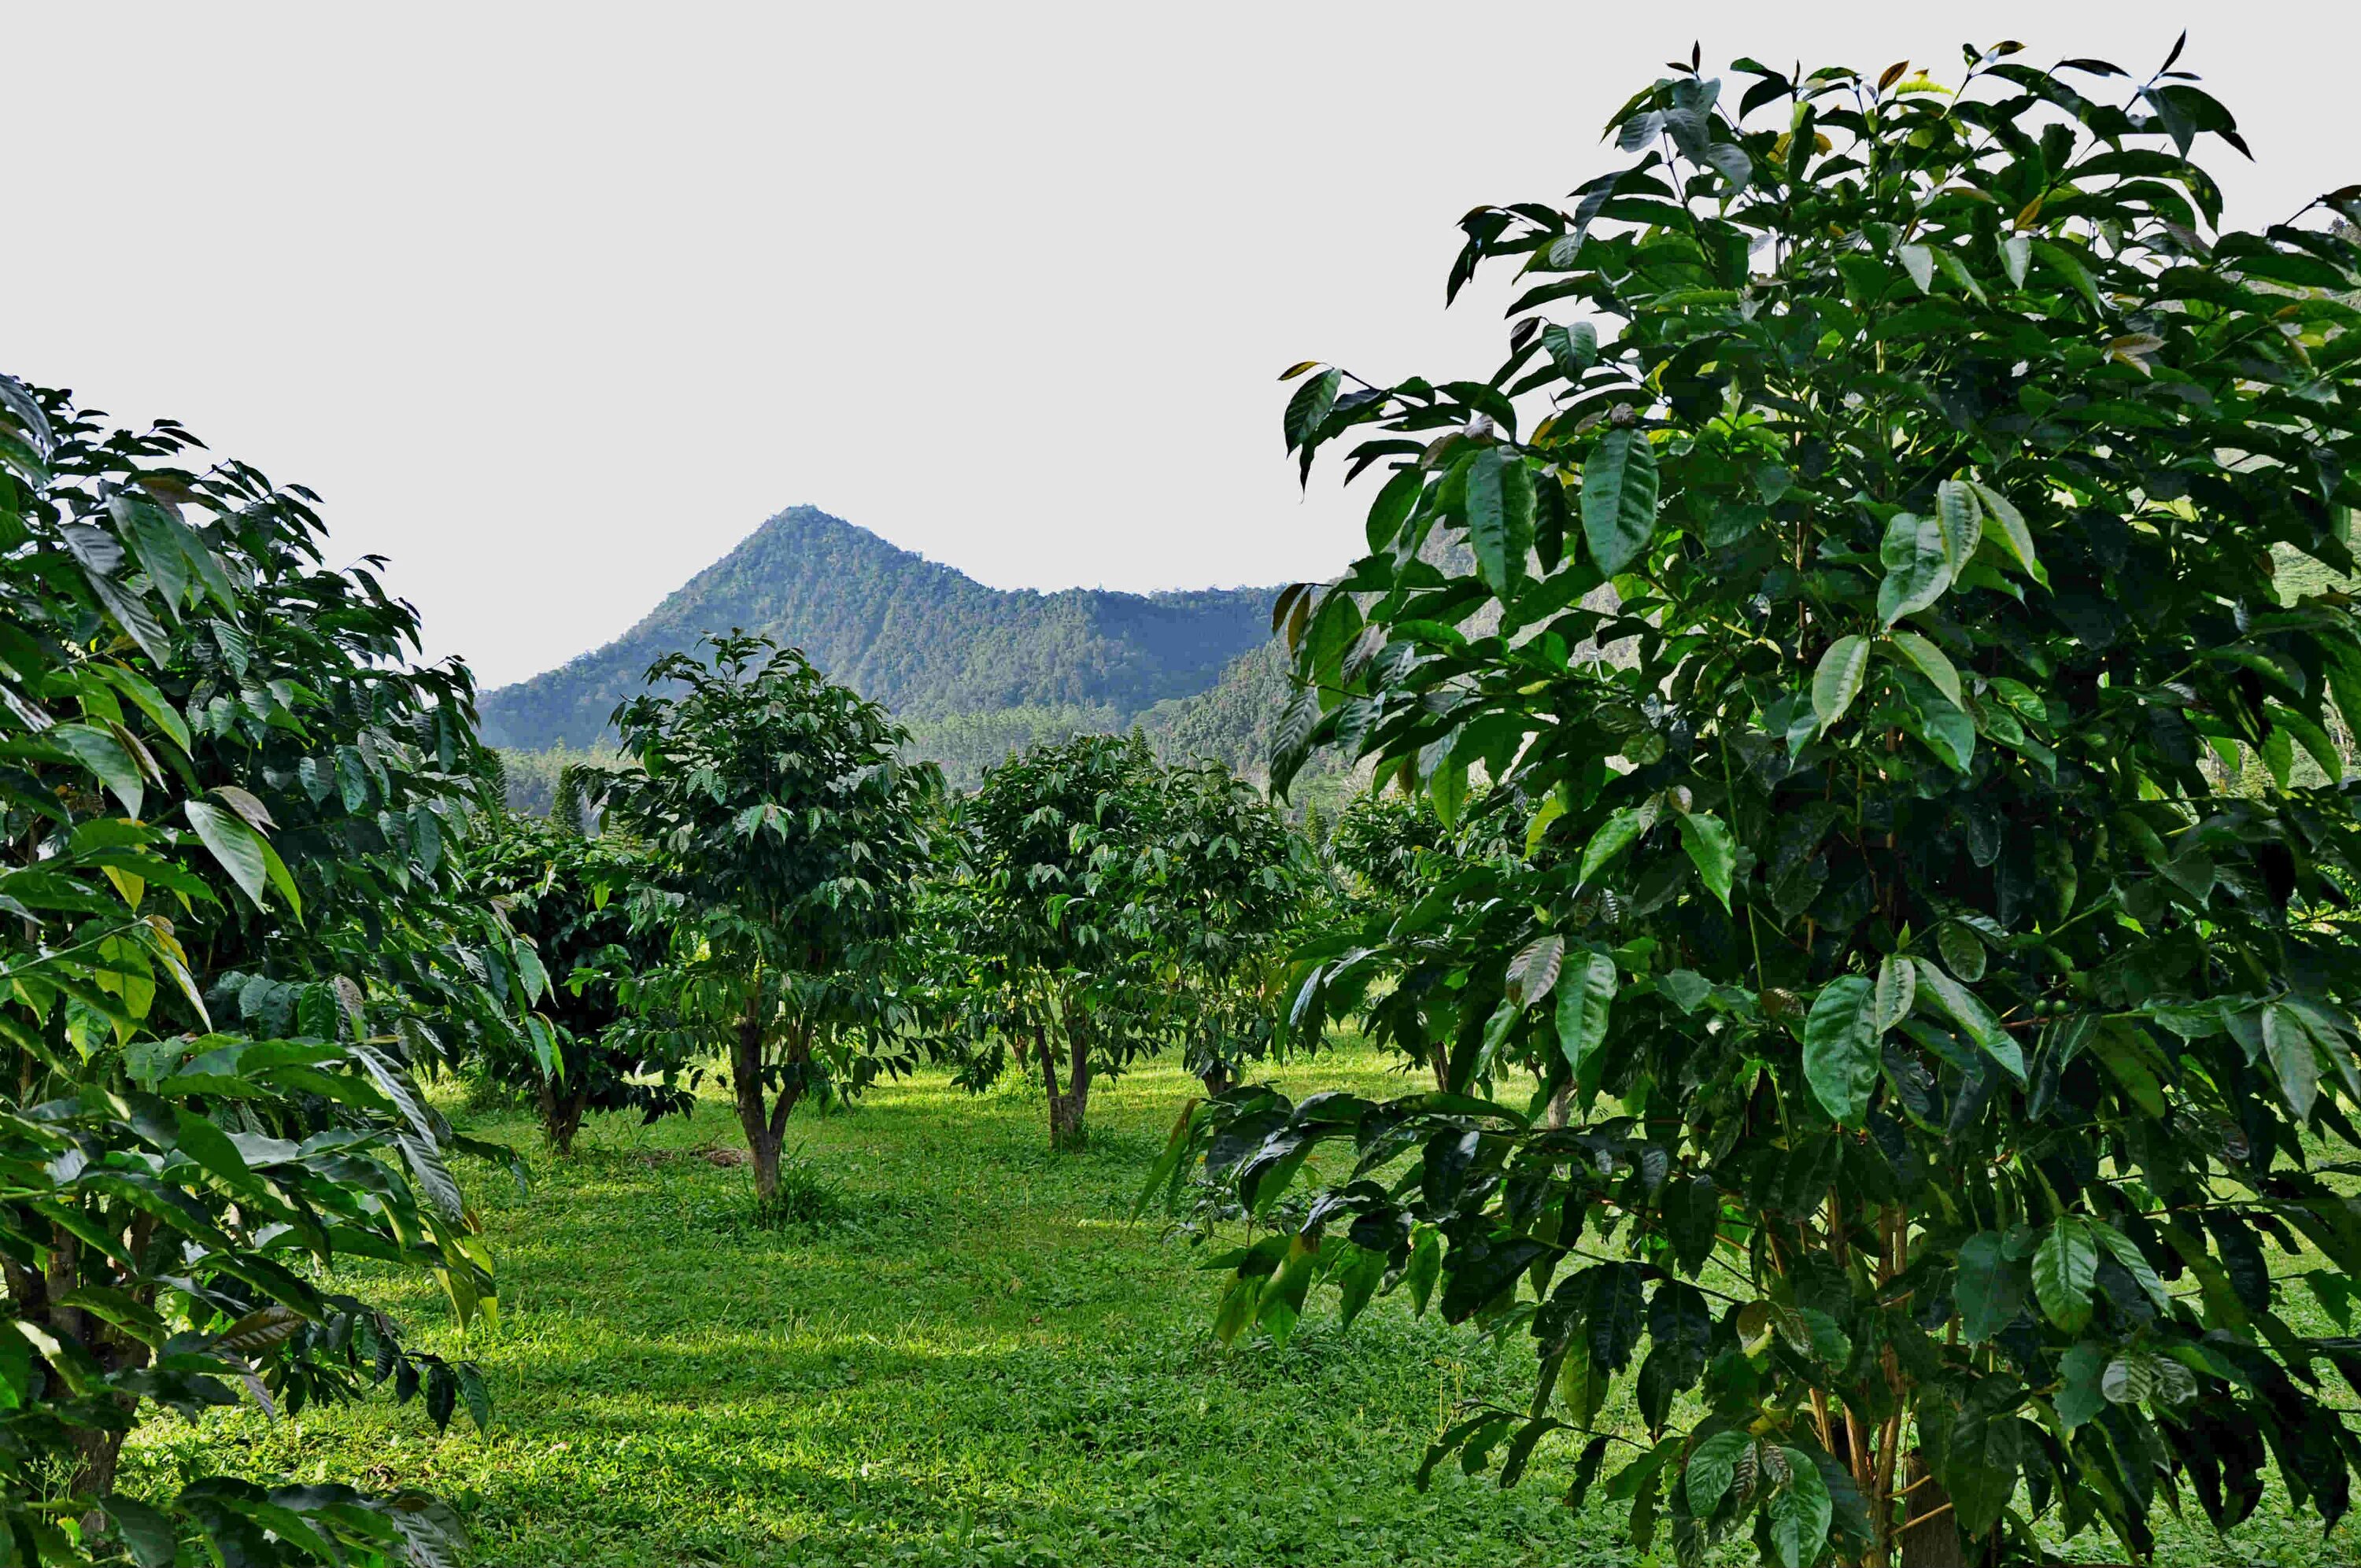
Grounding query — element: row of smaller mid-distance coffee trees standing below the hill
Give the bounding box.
[477,635,1320,1200]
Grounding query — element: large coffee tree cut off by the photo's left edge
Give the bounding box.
[0,378,493,1566]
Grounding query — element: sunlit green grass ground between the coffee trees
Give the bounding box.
[125,1051,2356,1566]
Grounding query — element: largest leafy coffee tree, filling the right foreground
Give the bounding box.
[1152,45,2361,1568]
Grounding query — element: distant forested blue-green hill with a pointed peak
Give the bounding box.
[482,505,1275,760]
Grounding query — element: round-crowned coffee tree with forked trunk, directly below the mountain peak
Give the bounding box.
[590,633,942,1202]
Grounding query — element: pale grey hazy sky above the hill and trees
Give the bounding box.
[18,0,2361,684]
